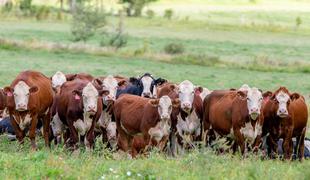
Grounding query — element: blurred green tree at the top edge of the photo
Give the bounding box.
[120,0,157,16]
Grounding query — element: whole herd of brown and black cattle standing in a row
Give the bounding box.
[0,71,308,159]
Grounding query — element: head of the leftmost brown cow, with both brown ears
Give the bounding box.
[4,81,39,111]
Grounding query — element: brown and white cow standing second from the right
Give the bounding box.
[204,88,264,154]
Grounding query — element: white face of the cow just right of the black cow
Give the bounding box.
[178,80,195,112]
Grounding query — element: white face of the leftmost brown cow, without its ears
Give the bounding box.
[13,81,30,111]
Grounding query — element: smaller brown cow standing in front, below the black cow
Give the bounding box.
[114,94,179,157]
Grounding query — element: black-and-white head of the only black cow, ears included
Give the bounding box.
[129,73,167,98]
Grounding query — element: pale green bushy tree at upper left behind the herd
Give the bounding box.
[71,6,106,42]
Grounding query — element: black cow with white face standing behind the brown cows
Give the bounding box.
[116,73,167,98]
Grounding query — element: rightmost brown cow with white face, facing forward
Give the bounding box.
[263,87,308,160]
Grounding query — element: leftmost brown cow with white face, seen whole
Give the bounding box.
[4,71,53,150]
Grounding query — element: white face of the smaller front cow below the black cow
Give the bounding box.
[158,96,172,120]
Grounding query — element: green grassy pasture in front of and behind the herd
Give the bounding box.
[0,1,310,179]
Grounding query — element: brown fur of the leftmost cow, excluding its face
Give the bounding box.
[5,71,53,149]
